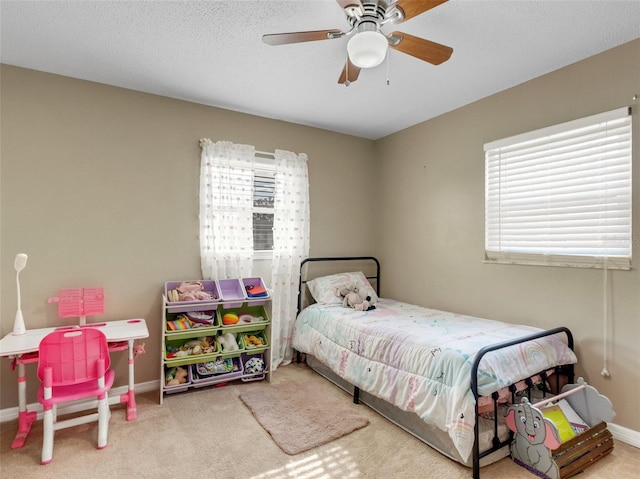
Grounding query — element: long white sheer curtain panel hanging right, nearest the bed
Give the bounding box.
[271,150,309,371]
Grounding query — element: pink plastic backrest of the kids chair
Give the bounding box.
[38,327,111,386]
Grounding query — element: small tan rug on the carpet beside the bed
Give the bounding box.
[240,381,369,455]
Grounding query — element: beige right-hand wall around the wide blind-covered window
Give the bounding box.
[376,40,640,431]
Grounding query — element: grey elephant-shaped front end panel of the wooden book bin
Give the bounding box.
[506,398,561,479]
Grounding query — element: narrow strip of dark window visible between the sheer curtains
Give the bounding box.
[253,164,275,251]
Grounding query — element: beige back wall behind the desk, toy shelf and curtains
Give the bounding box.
[0,65,375,409]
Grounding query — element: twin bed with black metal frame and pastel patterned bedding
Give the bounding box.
[293,257,576,478]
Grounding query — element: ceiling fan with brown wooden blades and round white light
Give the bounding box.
[262,0,453,86]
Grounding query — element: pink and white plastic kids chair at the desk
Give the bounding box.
[38,327,114,464]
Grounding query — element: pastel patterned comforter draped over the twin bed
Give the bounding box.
[293,298,576,462]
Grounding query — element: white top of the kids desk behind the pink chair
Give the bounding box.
[0,319,149,357]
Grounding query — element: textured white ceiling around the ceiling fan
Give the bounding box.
[0,0,640,139]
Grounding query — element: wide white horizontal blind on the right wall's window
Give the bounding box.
[484,108,632,269]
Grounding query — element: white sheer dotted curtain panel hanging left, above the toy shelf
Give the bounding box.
[200,138,255,279]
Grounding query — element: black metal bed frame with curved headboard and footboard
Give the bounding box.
[297,256,574,479]
